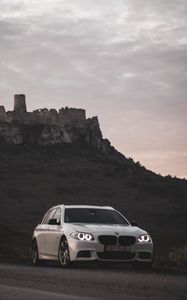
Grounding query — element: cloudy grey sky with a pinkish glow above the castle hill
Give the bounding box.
[0,0,187,178]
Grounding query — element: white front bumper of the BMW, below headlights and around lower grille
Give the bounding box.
[68,238,153,262]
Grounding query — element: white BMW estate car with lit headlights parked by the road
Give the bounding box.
[31,205,153,268]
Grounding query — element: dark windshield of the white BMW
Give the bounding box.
[65,208,129,225]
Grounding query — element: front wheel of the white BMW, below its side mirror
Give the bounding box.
[58,237,71,268]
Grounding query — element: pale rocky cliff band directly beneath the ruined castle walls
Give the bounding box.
[0,117,105,150]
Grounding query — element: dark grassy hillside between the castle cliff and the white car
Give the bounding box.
[0,131,187,228]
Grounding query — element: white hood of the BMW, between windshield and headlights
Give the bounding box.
[65,223,147,235]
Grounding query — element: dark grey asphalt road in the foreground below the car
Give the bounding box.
[0,263,187,300]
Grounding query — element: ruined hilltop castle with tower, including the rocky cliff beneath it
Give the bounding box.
[0,94,110,151]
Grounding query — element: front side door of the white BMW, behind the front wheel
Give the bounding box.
[46,207,62,256]
